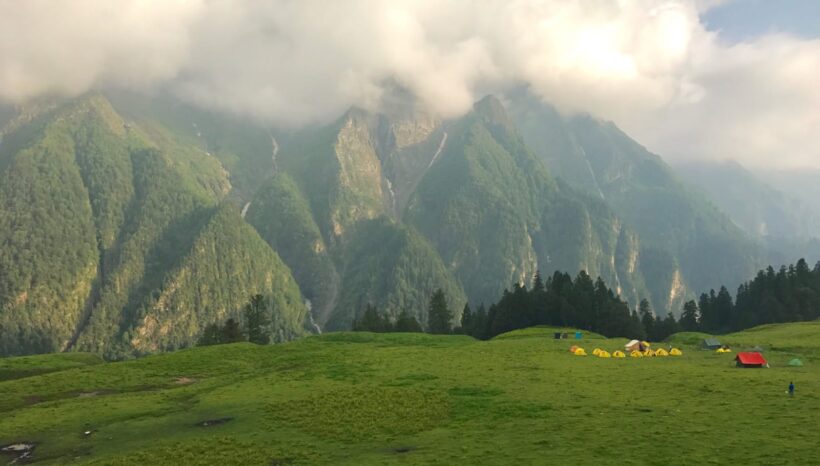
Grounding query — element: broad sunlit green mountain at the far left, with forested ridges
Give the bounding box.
[0,94,304,356]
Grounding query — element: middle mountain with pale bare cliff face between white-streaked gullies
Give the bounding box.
[260,109,466,329]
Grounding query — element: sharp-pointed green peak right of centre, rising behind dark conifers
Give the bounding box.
[404,97,645,308]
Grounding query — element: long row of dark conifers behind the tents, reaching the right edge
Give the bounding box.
[353,259,820,341]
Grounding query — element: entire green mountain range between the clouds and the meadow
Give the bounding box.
[0,94,800,357]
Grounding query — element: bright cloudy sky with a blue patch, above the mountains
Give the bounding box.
[0,0,820,169]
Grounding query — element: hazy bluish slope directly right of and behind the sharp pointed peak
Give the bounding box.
[512,97,765,311]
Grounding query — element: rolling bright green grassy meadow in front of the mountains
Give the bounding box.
[0,322,820,465]
